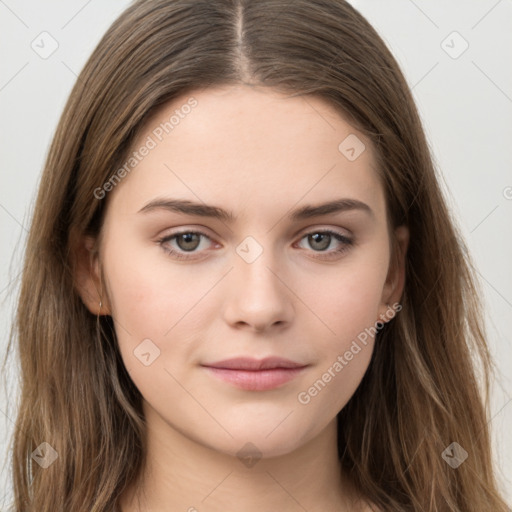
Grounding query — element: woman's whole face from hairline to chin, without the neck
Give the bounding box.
[82,86,401,456]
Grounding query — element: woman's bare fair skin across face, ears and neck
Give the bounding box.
[78,85,408,512]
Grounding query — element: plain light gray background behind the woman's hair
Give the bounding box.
[0,0,512,509]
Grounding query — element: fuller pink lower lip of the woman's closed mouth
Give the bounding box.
[206,366,305,391]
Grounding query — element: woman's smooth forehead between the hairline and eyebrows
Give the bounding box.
[106,85,384,220]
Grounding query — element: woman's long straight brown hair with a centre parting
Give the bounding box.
[4,0,507,512]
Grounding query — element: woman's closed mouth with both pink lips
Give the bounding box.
[201,357,309,391]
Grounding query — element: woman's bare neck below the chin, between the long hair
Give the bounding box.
[121,404,364,512]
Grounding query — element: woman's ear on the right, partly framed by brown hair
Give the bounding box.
[379,226,409,321]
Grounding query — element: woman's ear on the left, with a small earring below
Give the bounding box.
[73,236,111,315]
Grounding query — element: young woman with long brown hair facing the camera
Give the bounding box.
[3,0,507,512]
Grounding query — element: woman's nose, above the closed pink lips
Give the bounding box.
[224,251,294,332]
